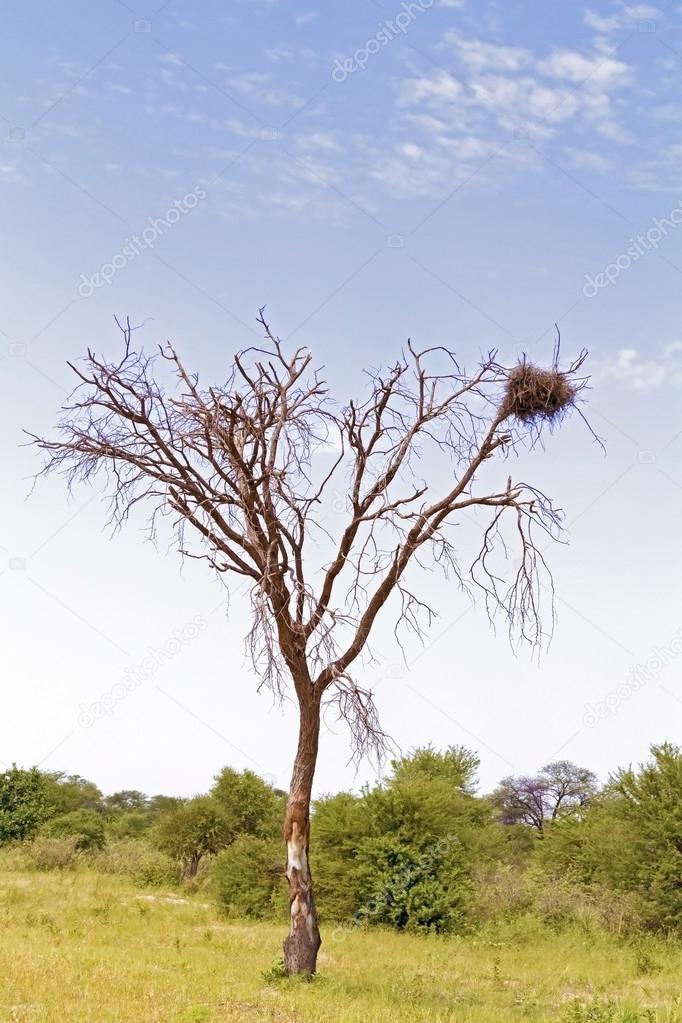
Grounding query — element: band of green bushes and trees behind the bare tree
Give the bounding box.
[0,744,682,937]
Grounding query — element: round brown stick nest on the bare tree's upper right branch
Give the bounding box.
[502,360,580,425]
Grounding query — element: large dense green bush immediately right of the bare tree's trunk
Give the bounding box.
[312,747,496,933]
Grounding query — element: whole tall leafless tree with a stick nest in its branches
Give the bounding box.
[34,310,585,974]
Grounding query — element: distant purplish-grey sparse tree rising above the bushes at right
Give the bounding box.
[491,760,597,835]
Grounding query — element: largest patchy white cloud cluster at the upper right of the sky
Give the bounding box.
[382,31,633,195]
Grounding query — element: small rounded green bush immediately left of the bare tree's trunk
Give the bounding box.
[212,835,286,920]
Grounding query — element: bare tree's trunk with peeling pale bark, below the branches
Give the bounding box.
[284,701,320,976]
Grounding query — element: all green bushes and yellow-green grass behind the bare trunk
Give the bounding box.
[0,744,682,1023]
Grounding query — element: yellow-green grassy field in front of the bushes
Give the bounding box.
[0,872,682,1023]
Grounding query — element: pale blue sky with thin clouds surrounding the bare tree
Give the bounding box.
[0,0,682,793]
